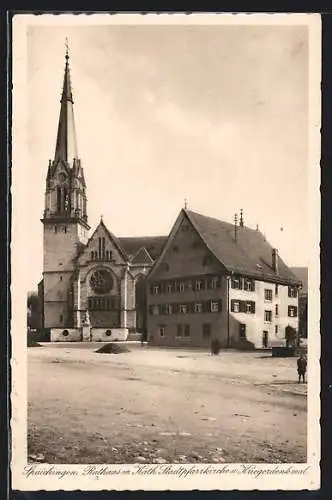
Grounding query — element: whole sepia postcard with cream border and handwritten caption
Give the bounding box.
[12,14,320,489]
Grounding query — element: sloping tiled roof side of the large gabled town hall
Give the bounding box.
[187,210,299,284]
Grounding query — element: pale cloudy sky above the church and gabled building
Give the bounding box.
[22,20,308,287]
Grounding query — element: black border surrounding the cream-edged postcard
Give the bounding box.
[0,5,332,500]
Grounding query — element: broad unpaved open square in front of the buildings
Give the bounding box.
[28,344,307,464]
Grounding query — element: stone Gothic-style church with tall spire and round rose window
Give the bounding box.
[38,50,167,341]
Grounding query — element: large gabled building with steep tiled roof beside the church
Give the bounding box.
[147,209,301,348]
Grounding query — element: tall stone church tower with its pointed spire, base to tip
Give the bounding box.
[42,47,90,328]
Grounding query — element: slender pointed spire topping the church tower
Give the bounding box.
[54,39,77,163]
